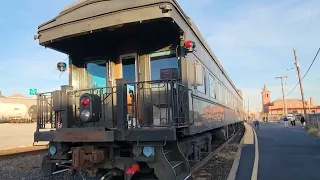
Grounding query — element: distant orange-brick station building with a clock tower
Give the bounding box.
[261,85,320,119]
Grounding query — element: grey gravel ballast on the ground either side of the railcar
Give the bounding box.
[0,126,244,180]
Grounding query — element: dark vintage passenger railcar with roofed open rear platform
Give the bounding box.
[34,0,243,180]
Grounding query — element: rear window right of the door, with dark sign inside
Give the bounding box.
[150,51,179,81]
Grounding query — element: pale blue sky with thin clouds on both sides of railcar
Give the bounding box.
[0,0,320,112]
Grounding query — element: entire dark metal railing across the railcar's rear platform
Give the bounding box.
[37,79,189,131]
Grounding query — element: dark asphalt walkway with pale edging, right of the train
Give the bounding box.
[230,123,320,180]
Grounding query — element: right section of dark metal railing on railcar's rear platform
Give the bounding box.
[126,80,189,128]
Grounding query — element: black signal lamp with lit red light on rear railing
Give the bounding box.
[79,93,101,122]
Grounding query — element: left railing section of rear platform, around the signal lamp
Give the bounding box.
[37,87,116,131]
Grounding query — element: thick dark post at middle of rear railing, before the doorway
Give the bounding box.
[116,78,128,129]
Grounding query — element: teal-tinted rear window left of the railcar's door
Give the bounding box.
[85,61,107,88]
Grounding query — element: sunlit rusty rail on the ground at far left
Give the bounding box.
[0,146,48,161]
